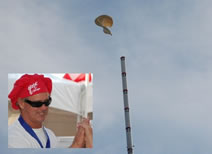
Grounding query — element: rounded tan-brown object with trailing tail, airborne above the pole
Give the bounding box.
[95,15,113,35]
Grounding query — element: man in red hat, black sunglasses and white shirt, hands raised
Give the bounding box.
[8,74,93,148]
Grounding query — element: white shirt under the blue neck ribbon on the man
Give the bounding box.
[8,120,58,148]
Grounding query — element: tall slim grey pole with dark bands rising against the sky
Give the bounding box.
[120,56,133,154]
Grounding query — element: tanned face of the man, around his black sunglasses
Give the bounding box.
[21,93,49,124]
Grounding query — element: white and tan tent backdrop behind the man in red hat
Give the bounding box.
[8,73,93,147]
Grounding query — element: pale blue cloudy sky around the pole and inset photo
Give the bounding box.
[0,0,212,154]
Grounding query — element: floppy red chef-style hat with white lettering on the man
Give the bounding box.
[8,74,52,110]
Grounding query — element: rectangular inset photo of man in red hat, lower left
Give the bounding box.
[8,73,93,148]
